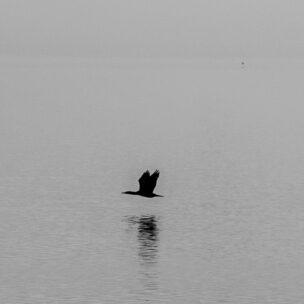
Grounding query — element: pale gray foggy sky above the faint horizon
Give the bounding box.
[0,0,304,58]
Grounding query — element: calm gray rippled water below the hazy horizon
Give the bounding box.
[0,62,304,304]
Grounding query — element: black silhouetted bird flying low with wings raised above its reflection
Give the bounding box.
[122,170,163,198]
